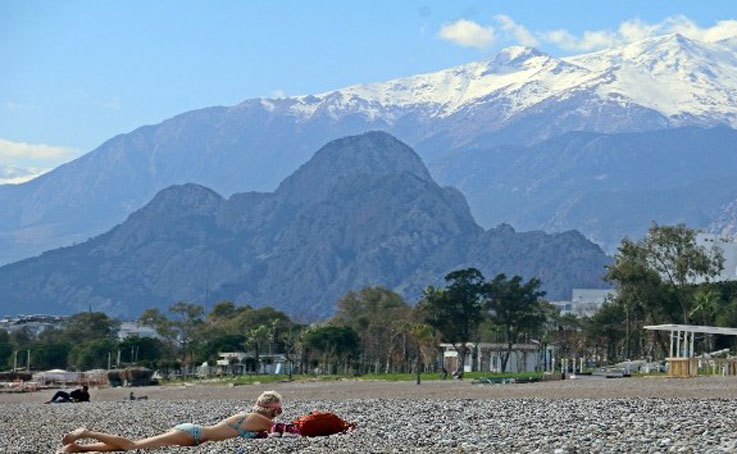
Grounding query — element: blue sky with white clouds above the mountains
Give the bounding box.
[0,0,737,172]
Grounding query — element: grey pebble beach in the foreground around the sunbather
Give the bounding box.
[0,377,737,454]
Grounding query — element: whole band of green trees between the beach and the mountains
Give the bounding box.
[0,225,737,374]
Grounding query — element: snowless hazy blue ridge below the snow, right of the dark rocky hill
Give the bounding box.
[435,128,737,251]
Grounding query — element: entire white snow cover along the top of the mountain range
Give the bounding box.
[278,34,737,127]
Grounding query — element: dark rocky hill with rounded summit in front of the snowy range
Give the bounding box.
[0,132,609,319]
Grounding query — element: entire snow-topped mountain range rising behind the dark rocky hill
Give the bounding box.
[0,34,737,264]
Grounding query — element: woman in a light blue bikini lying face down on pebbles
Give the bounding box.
[57,391,282,453]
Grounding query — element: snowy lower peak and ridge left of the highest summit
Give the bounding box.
[291,46,590,122]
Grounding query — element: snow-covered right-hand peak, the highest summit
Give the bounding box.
[567,34,737,126]
